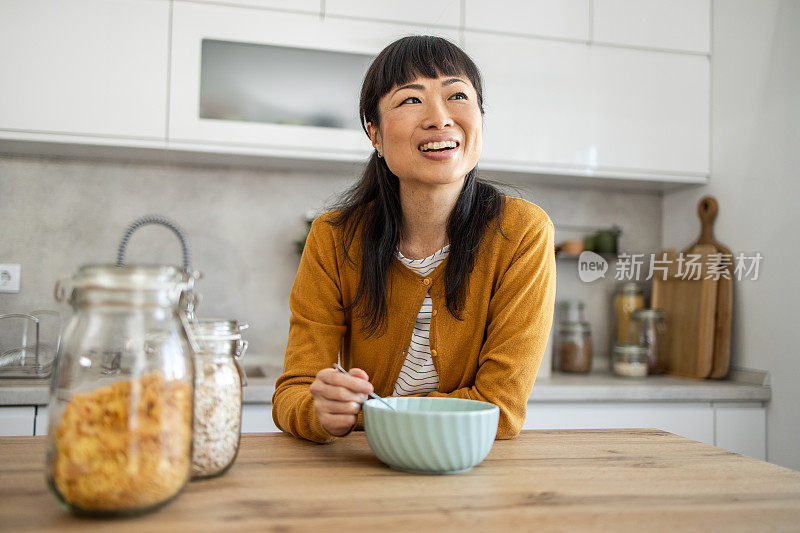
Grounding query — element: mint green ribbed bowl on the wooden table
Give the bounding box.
[364,397,500,474]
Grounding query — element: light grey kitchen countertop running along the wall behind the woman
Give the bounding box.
[0,357,772,406]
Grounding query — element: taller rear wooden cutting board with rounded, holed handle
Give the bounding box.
[684,196,733,379]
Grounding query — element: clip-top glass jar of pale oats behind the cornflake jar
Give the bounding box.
[190,319,248,479]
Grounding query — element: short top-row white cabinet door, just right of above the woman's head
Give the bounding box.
[464,0,590,41]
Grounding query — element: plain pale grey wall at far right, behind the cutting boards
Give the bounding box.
[663,0,800,469]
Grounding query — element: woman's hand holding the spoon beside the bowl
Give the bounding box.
[309,368,373,436]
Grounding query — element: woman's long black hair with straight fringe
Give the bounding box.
[331,35,505,336]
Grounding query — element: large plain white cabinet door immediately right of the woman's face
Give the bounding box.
[464,31,594,168]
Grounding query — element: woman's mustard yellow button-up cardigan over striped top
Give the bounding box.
[272,197,556,442]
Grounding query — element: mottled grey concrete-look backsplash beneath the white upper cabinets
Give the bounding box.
[0,152,661,375]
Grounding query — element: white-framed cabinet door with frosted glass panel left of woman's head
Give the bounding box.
[168,1,458,160]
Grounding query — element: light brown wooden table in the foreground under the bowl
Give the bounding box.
[0,429,800,533]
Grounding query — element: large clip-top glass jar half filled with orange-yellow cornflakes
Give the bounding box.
[46,265,194,516]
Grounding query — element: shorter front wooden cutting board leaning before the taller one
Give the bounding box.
[651,244,719,378]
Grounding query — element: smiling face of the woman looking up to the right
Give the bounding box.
[367,76,483,185]
